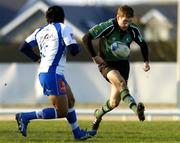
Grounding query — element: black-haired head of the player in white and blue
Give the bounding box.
[46,6,65,23]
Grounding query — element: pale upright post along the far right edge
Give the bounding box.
[177,0,180,109]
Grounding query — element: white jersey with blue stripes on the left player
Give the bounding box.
[25,23,76,74]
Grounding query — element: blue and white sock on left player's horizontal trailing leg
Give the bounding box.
[36,108,58,119]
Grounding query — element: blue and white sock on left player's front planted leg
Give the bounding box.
[66,108,80,136]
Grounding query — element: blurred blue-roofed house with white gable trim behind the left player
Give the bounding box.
[0,0,114,43]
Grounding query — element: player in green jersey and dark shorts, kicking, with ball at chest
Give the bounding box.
[83,5,150,133]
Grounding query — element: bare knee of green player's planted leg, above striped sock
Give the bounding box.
[109,84,121,108]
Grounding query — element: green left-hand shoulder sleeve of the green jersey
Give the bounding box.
[89,19,113,39]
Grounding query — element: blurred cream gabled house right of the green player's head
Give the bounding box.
[134,3,177,41]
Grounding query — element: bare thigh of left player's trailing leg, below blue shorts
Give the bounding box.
[48,95,68,117]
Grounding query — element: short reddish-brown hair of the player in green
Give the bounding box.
[117,5,134,18]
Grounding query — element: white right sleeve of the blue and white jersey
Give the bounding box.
[62,25,77,46]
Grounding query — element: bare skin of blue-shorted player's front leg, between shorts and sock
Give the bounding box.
[66,84,75,108]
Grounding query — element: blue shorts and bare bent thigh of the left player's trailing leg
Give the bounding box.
[39,73,68,117]
